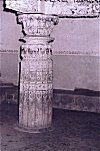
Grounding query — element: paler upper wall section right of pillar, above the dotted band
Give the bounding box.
[52,18,99,52]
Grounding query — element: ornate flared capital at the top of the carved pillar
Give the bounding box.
[18,14,58,36]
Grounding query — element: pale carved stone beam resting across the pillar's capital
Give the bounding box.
[6,0,100,17]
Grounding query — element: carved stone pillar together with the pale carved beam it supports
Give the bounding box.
[5,0,100,131]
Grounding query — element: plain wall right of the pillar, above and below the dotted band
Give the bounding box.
[52,18,100,90]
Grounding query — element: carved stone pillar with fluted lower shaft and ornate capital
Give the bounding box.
[18,14,58,131]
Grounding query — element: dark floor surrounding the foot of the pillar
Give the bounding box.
[0,104,100,151]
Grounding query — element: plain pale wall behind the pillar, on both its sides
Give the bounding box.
[0,2,100,90]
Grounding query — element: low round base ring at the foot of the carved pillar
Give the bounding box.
[14,124,54,133]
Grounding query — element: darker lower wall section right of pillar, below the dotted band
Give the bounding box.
[53,55,100,91]
